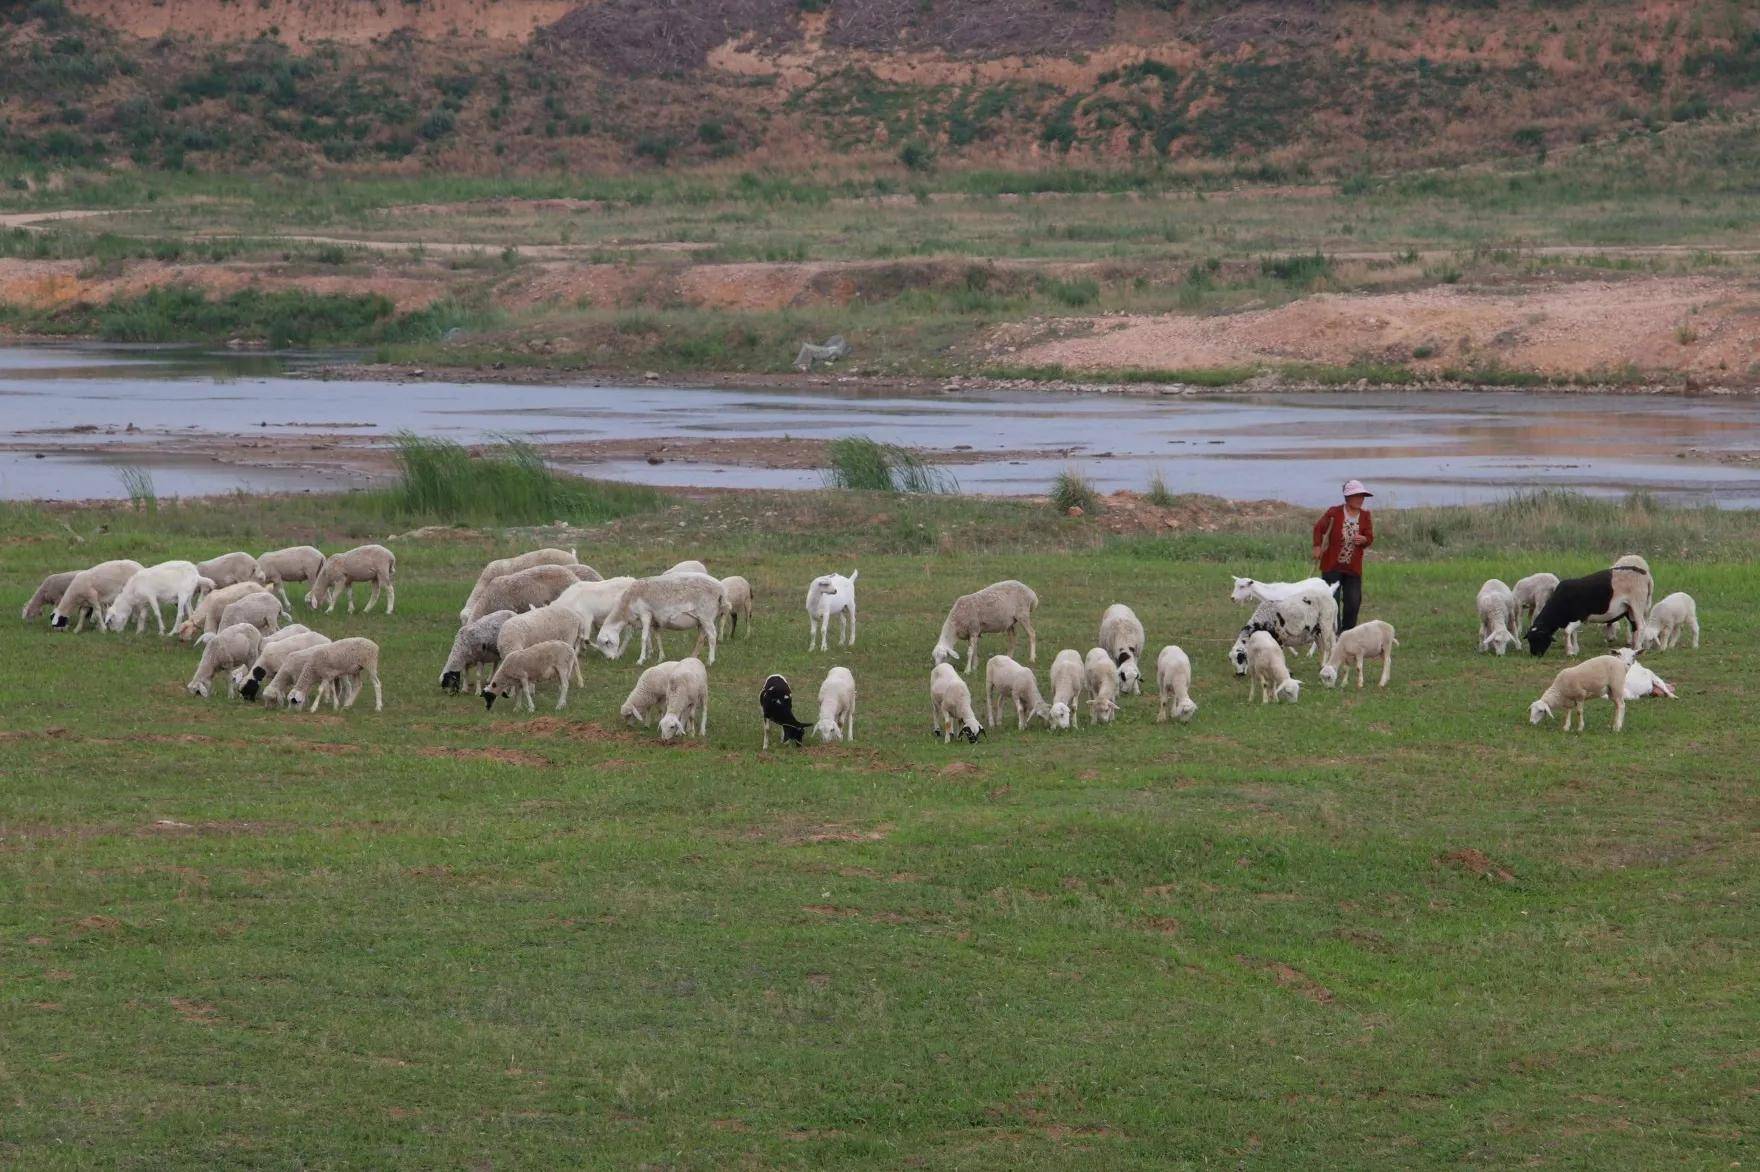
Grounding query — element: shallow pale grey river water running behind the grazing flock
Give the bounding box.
[0,337,1760,509]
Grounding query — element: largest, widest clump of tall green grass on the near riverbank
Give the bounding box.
[375,433,665,524]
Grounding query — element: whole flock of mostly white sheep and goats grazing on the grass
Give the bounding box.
[25,546,1698,748]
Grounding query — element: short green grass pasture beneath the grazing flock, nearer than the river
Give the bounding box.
[0,494,1760,1168]
